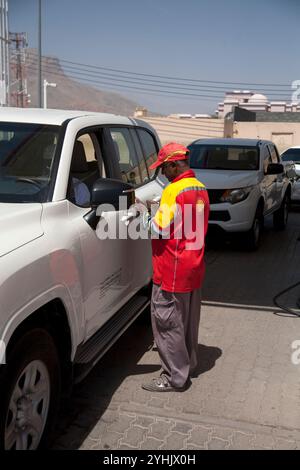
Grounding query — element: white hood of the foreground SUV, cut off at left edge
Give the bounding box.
[0,203,44,257]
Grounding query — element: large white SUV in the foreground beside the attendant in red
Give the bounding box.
[0,108,165,449]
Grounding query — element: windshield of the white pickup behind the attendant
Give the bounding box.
[189,144,259,170]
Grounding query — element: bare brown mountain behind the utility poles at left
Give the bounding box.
[26,49,139,115]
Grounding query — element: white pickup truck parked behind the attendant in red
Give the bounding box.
[189,139,291,249]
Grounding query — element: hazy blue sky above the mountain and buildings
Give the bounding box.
[8,0,300,113]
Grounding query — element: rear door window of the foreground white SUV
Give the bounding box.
[109,127,142,186]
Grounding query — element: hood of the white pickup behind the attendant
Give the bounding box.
[193,169,260,189]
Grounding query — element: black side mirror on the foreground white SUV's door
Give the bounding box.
[91,178,135,211]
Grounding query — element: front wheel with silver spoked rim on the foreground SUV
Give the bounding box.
[0,329,61,450]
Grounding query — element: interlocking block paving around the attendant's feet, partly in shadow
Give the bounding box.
[53,211,300,450]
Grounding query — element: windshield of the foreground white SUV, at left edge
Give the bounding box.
[0,122,60,202]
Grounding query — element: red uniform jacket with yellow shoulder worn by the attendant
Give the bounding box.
[151,170,209,292]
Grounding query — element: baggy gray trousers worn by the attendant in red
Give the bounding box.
[151,284,201,387]
